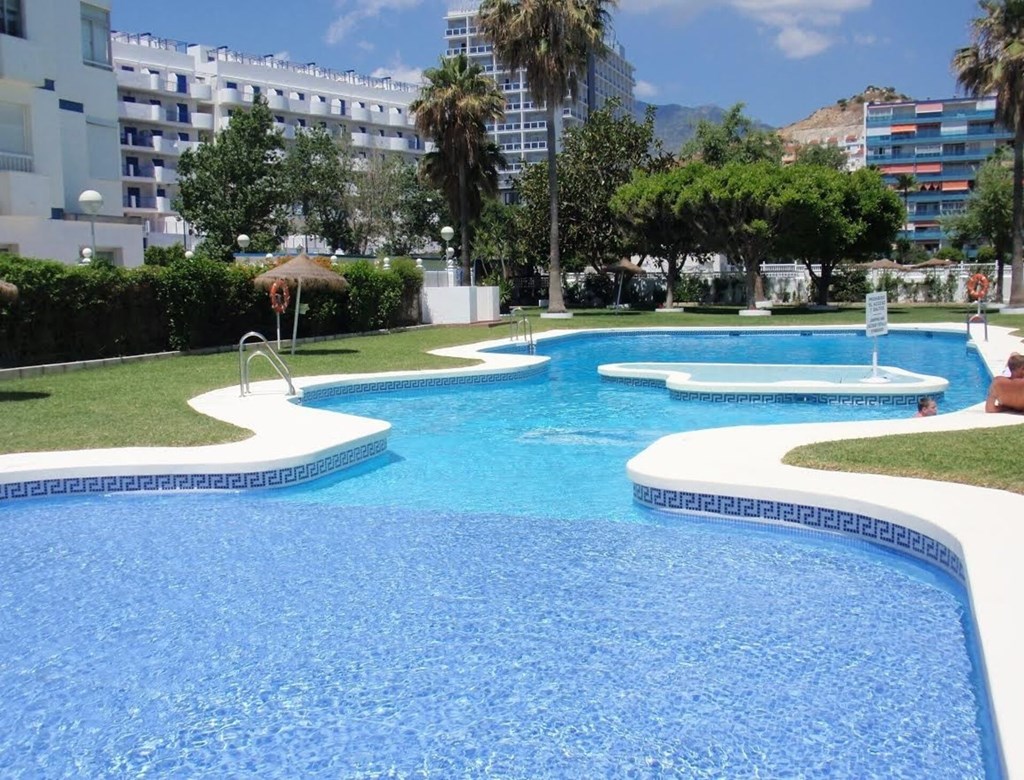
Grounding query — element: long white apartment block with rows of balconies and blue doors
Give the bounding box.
[113,34,427,247]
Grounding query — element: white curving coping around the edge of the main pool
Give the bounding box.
[0,323,1024,778]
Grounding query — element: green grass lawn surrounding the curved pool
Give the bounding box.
[0,305,1024,492]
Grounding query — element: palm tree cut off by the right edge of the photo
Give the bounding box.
[952,0,1024,306]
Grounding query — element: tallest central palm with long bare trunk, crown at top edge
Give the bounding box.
[480,0,615,313]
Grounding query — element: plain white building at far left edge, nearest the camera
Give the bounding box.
[0,0,142,265]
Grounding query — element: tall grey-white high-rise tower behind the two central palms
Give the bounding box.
[444,8,636,200]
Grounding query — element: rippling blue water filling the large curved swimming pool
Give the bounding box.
[0,327,996,778]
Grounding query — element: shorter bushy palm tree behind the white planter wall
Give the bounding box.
[409,53,505,285]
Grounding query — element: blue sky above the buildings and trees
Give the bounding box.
[112,0,978,126]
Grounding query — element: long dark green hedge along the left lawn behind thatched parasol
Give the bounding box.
[0,254,423,367]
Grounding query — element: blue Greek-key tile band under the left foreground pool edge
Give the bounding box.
[0,438,387,502]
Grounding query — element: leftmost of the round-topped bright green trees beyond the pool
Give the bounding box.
[611,163,710,308]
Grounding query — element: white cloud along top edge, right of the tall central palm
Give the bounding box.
[620,0,872,59]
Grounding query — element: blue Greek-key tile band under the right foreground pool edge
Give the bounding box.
[633,483,967,583]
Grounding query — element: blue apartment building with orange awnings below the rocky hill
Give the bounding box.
[864,97,1013,252]
